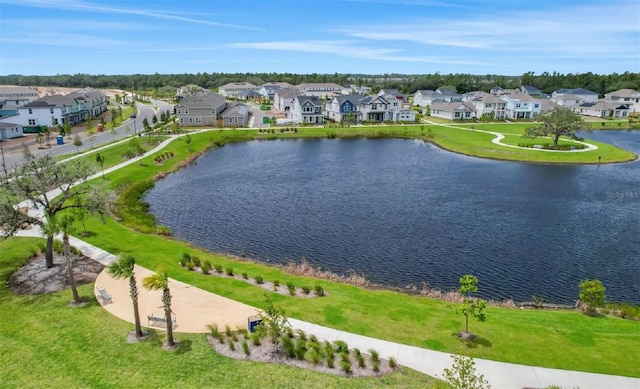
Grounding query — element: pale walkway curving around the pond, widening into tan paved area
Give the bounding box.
[10,129,640,389]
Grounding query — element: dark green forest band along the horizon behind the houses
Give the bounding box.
[0,72,640,96]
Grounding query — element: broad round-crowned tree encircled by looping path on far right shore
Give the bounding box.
[523,107,591,148]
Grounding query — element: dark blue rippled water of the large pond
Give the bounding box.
[146,131,640,303]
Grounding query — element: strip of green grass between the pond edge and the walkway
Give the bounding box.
[41,126,640,377]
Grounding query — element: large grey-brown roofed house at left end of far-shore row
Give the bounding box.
[176,92,227,126]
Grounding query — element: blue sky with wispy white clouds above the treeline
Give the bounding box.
[0,0,640,75]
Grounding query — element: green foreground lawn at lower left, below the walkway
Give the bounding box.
[0,238,445,388]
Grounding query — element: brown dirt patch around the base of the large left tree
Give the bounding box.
[7,254,104,294]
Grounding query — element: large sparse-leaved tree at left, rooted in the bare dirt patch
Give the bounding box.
[0,155,108,268]
